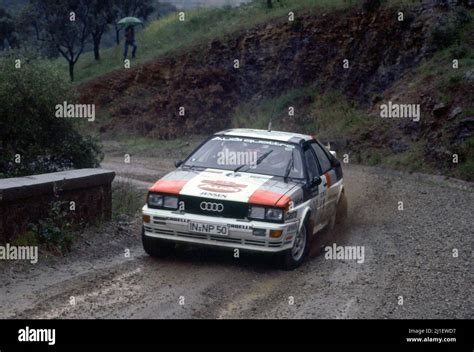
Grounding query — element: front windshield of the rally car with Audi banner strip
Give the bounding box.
[184,136,304,178]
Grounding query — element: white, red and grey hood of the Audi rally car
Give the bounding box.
[149,169,298,207]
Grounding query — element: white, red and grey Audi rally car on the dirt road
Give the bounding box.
[142,129,347,269]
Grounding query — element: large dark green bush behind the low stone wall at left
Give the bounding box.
[0,54,101,177]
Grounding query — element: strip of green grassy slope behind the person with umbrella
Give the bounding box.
[57,0,358,82]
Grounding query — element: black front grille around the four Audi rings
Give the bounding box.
[179,195,249,219]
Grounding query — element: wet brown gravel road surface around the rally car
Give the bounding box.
[0,159,474,319]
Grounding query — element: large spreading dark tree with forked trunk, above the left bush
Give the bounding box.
[30,0,94,81]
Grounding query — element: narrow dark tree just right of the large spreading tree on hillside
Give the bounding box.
[90,0,118,60]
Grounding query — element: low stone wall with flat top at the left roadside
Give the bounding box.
[0,169,115,243]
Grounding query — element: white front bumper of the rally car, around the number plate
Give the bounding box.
[142,205,298,253]
